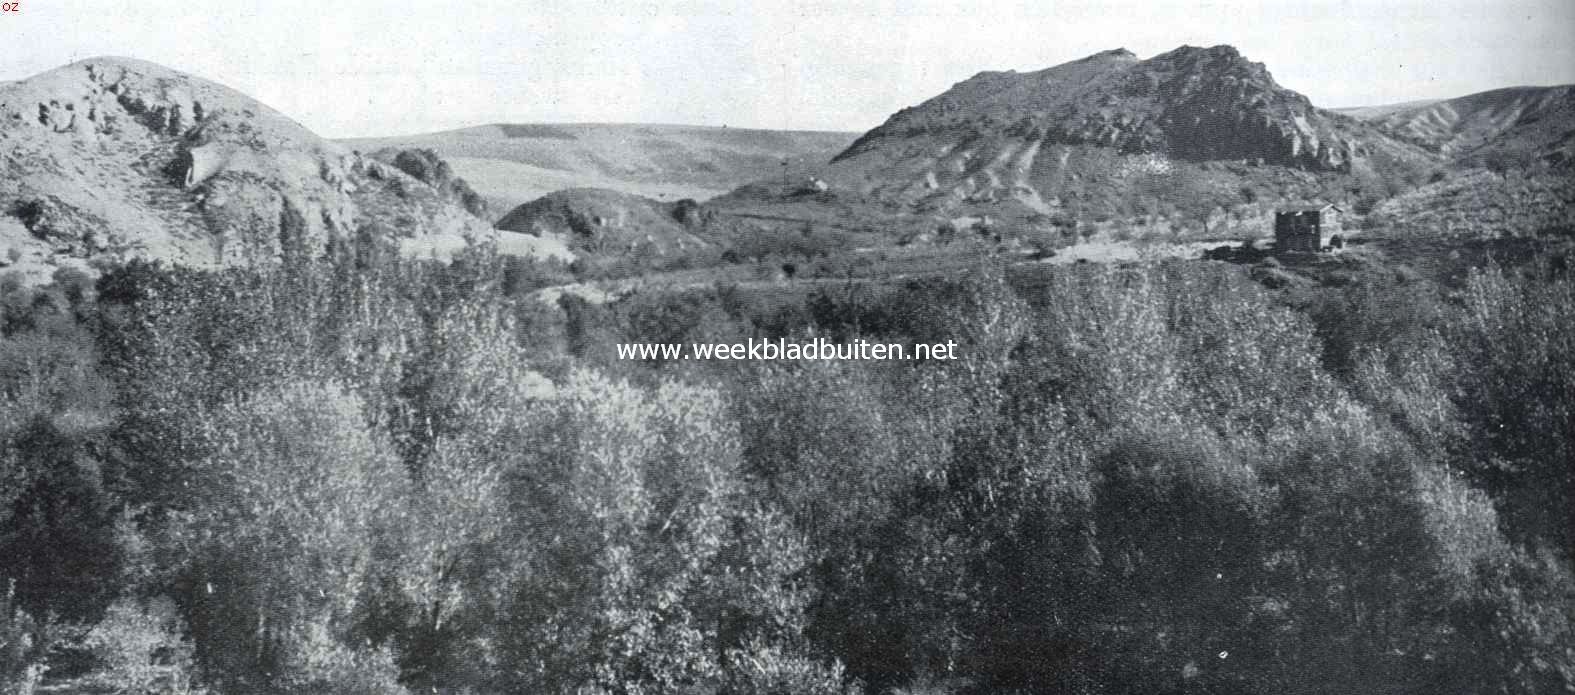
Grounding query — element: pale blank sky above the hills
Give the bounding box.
[0,0,1575,137]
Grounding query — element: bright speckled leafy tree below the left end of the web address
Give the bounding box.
[499,370,739,690]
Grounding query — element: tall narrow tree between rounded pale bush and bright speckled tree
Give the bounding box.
[369,304,548,679]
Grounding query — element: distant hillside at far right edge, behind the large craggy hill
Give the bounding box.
[1348,85,1575,167]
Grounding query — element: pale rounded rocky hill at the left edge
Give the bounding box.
[0,58,564,281]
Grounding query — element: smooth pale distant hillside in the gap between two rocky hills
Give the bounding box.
[343,123,855,214]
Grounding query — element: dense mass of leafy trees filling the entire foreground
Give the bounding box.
[0,245,1575,693]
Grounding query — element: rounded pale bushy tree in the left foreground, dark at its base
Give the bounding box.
[169,383,406,678]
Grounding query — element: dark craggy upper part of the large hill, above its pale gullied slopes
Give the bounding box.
[836,46,1386,170]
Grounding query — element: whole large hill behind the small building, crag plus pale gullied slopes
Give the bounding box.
[827,46,1438,230]
